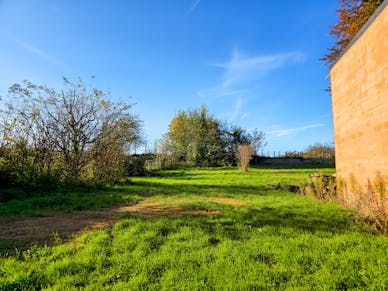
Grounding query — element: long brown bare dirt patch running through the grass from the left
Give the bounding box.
[0,199,219,245]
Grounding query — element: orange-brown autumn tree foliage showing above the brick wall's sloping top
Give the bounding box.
[321,0,383,65]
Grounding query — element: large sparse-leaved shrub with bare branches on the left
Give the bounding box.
[1,78,140,181]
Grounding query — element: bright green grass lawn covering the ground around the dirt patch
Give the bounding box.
[0,168,388,290]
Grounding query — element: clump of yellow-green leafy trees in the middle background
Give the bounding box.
[165,105,265,166]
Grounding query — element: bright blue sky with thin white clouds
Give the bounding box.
[0,0,338,152]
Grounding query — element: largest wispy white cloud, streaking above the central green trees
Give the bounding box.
[197,49,305,98]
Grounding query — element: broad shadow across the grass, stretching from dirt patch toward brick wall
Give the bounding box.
[114,202,354,245]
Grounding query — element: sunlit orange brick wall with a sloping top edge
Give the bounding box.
[330,6,388,214]
